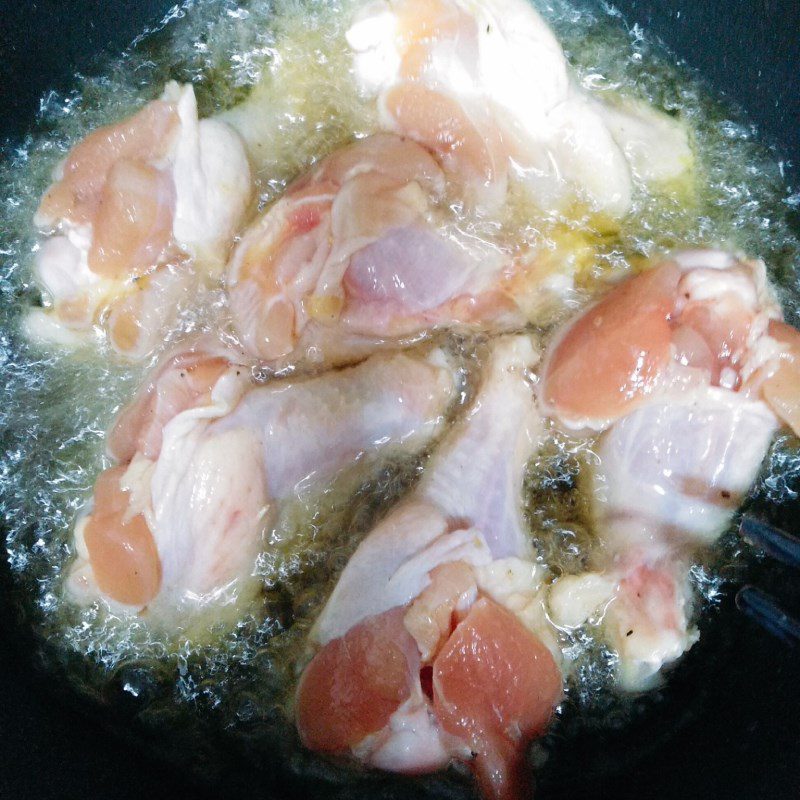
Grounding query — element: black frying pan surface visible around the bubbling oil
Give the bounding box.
[0,0,800,800]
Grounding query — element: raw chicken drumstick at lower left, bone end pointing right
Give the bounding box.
[70,342,456,625]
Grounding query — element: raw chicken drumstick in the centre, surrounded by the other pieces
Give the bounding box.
[227,134,526,365]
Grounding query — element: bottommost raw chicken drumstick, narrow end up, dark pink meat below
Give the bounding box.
[295,336,562,798]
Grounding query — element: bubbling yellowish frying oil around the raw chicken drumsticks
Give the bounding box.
[0,0,800,793]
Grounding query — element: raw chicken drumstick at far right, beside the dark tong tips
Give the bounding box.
[540,251,800,689]
